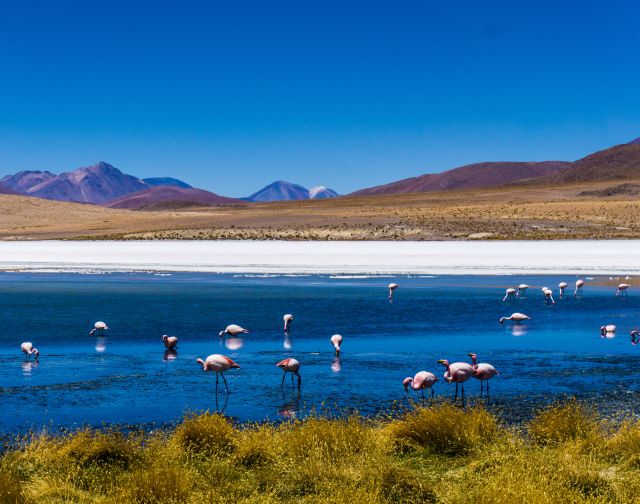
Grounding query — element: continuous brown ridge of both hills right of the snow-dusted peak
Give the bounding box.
[349,138,640,196]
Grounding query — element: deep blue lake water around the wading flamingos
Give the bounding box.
[0,273,640,433]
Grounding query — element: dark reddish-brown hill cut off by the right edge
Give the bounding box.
[535,139,640,184]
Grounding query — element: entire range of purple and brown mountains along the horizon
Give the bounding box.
[0,138,640,209]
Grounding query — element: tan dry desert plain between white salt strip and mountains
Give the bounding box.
[0,182,640,240]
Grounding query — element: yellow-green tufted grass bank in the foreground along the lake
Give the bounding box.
[0,402,640,504]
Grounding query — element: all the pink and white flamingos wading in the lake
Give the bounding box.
[20,279,640,404]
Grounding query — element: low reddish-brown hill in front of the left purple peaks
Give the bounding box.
[104,186,246,209]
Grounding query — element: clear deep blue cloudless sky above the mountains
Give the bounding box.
[0,0,640,196]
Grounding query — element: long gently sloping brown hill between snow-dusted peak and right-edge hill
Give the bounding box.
[349,161,571,196]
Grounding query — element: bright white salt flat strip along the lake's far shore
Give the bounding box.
[0,240,640,275]
